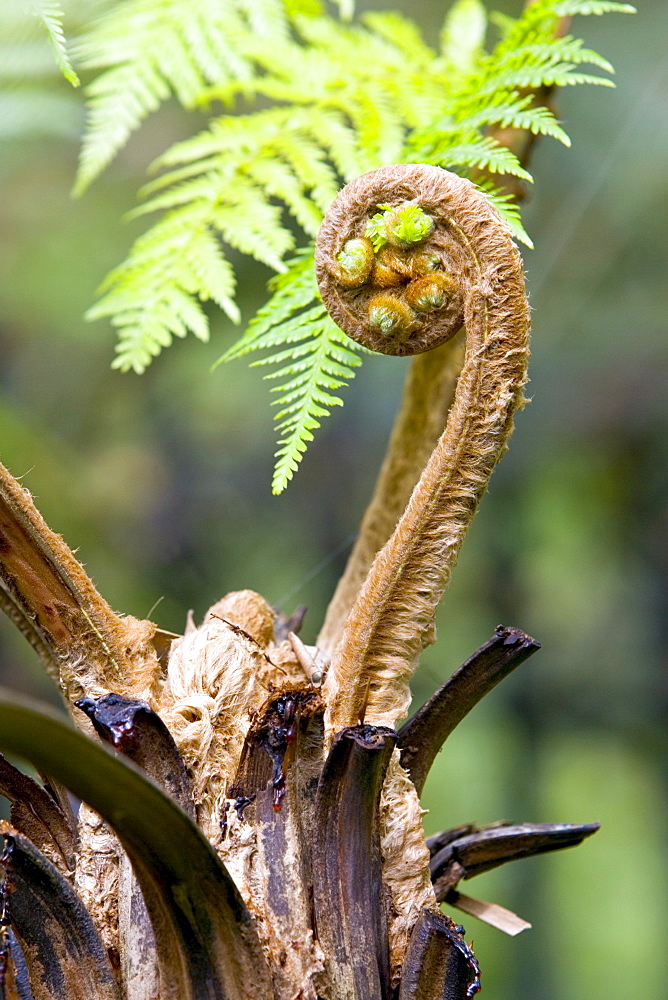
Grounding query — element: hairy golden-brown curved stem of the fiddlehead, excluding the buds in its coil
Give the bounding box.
[316,164,529,733]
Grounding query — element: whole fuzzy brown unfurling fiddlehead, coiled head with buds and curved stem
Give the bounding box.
[316,164,529,734]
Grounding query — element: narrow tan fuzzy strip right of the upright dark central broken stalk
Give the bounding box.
[380,750,437,985]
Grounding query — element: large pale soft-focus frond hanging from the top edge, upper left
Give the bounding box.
[74,0,287,194]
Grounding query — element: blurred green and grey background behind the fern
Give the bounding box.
[0,0,668,1000]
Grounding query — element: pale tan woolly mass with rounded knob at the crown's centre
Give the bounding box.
[160,591,332,1000]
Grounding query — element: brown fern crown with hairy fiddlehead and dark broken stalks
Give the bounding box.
[0,165,596,1000]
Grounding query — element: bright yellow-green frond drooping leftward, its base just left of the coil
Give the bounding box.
[87,98,366,371]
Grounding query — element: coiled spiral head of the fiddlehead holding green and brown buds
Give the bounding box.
[315,164,464,356]
